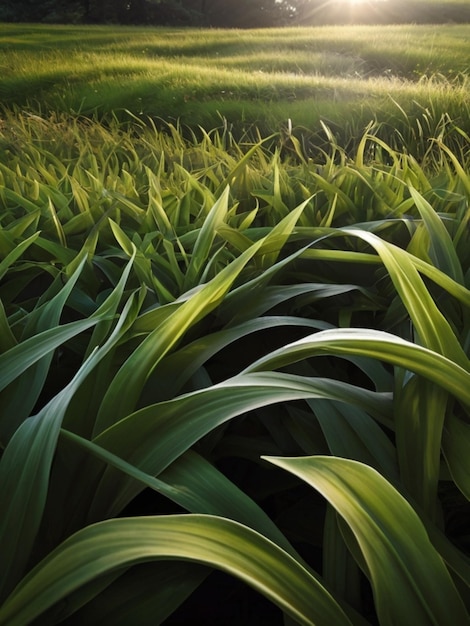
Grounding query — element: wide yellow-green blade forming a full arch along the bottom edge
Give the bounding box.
[0,515,351,626]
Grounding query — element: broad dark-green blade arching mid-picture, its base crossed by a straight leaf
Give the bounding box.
[90,372,392,521]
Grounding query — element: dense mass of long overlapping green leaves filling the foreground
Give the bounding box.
[0,116,470,626]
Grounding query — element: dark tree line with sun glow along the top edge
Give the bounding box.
[0,0,470,28]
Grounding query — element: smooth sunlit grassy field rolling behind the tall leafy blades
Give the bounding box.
[0,25,470,134]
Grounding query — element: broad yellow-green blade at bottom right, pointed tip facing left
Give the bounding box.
[266,457,470,626]
